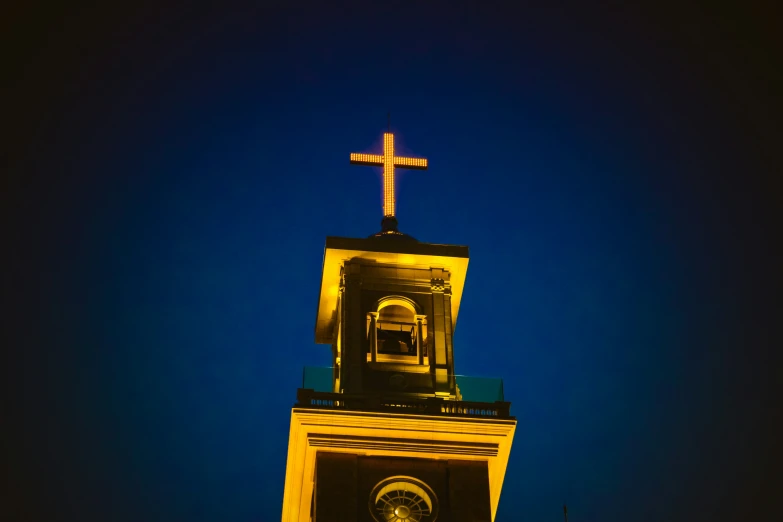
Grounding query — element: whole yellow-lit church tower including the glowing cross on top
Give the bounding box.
[282,133,516,522]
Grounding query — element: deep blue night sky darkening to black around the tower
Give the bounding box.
[0,2,783,522]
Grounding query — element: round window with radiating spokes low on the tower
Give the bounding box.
[370,476,438,522]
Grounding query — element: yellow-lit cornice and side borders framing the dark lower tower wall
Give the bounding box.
[281,407,517,522]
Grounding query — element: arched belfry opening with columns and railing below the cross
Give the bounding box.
[367,296,426,364]
